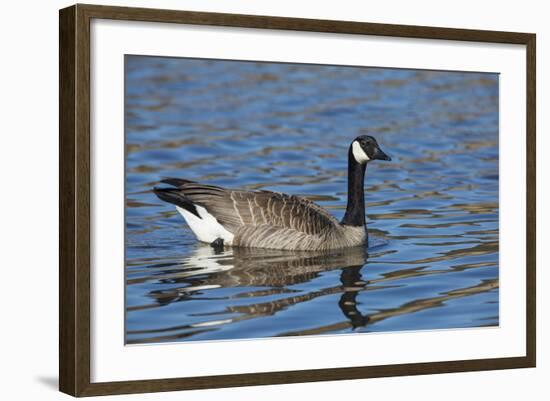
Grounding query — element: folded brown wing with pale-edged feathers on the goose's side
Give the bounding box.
[170,180,338,235]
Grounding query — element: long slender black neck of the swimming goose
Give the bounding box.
[342,147,367,227]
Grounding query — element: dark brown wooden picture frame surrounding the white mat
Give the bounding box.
[59,4,536,396]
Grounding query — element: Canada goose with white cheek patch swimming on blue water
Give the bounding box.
[154,135,391,251]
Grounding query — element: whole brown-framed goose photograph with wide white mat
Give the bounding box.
[60,5,536,396]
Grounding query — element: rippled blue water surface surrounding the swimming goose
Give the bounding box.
[125,56,499,344]
